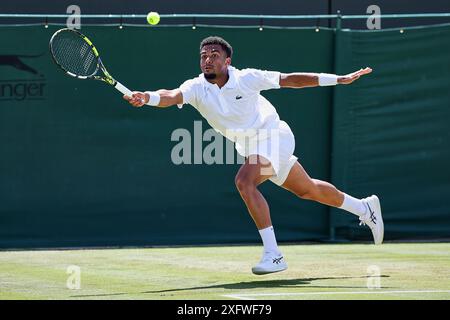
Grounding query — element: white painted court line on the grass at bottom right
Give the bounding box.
[222,289,450,300]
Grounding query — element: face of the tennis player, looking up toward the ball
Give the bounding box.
[200,44,231,79]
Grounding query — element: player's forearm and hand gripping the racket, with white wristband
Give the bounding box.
[123,89,183,108]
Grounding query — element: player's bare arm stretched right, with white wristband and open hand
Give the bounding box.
[280,68,372,88]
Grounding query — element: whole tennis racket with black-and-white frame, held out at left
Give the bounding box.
[50,29,132,96]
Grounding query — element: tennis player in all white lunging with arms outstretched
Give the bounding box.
[124,37,384,275]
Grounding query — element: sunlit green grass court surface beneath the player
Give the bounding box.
[0,243,450,300]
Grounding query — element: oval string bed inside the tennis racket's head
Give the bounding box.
[52,32,97,77]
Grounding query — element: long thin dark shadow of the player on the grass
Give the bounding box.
[71,275,390,298]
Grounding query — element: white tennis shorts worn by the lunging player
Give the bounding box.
[235,121,298,186]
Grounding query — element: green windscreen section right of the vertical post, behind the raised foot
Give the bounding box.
[331,25,450,239]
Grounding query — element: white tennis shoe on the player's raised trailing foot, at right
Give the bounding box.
[359,195,384,244]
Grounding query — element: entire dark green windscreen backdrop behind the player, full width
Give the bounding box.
[0,26,450,248]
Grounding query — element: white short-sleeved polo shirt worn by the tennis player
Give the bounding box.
[178,66,280,142]
